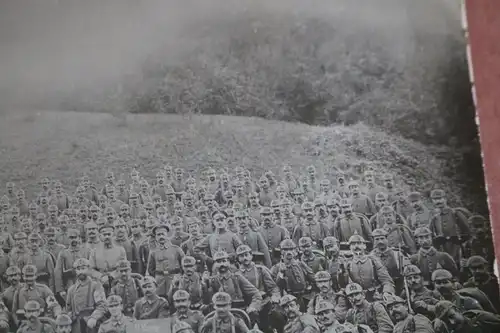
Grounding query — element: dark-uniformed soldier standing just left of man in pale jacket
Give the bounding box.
[54,229,91,299]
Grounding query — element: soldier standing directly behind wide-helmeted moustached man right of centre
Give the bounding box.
[333,199,372,242]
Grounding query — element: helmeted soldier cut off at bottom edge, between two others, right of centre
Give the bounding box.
[384,295,434,333]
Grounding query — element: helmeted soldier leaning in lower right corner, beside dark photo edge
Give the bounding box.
[432,269,483,311]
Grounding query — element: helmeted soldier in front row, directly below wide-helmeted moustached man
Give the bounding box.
[345,283,394,333]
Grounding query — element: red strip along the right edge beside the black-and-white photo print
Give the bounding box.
[464,0,500,268]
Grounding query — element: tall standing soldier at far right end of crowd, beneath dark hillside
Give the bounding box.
[430,190,470,264]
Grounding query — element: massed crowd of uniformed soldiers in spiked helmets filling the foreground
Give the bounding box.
[0,165,500,333]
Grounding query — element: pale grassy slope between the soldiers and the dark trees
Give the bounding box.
[0,112,472,207]
